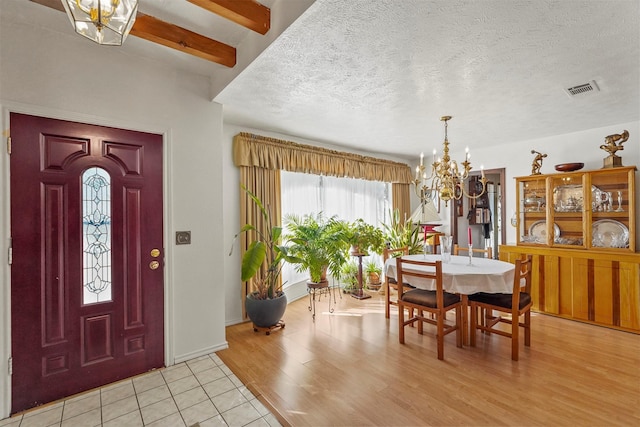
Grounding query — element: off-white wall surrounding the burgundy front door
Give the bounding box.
[0,0,227,418]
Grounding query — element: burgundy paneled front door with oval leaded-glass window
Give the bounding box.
[10,113,164,413]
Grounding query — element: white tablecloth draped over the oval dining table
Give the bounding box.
[385,255,515,295]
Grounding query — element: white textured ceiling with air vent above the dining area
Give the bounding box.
[215,0,640,157]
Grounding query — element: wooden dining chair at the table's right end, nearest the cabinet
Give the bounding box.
[468,255,532,360]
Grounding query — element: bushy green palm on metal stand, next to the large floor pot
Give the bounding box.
[285,213,346,283]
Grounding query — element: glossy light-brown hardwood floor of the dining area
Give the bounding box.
[217,292,640,426]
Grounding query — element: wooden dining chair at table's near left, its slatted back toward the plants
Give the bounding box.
[396,257,462,360]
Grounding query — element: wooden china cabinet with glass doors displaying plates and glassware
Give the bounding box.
[500,166,640,333]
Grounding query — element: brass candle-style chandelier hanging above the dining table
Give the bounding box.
[413,116,487,206]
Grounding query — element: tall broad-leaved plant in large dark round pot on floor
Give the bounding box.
[229,186,295,329]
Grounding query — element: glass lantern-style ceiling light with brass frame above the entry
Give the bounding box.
[62,0,138,46]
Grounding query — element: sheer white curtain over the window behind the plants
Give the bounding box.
[280,171,391,287]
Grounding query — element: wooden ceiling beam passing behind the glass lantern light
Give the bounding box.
[31,0,236,68]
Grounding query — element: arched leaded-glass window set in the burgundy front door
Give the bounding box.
[82,167,112,304]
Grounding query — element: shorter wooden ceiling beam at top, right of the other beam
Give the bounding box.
[187,0,271,35]
